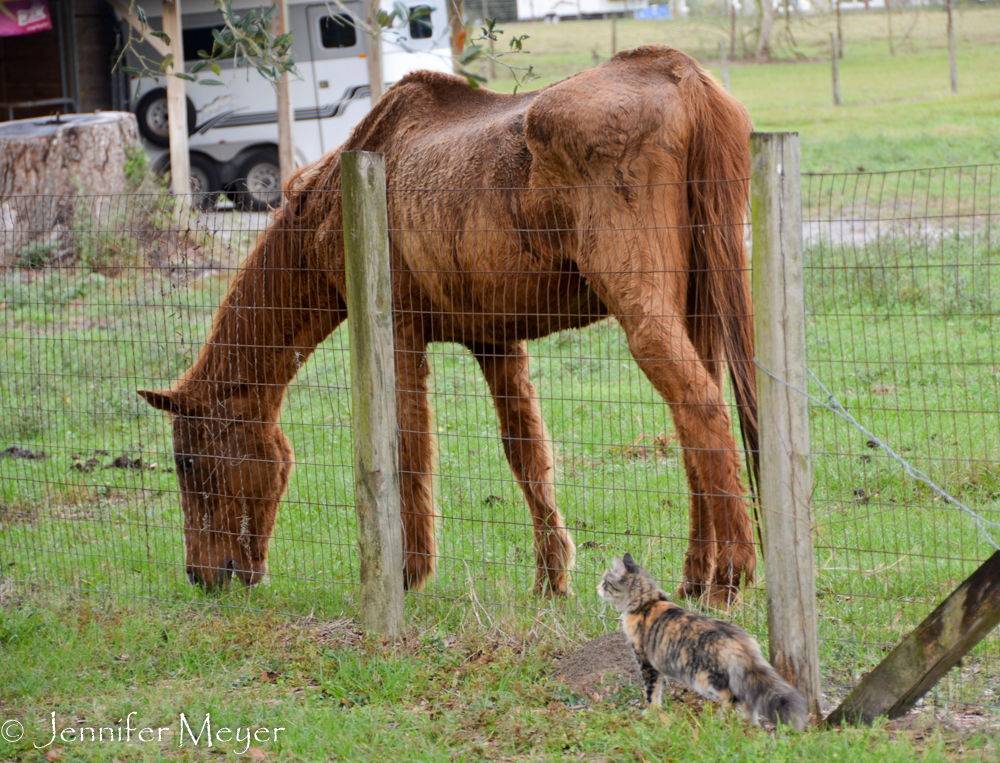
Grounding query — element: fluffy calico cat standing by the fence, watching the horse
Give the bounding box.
[597,554,806,731]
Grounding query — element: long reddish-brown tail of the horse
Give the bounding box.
[680,65,760,516]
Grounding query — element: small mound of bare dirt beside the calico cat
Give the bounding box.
[553,631,642,702]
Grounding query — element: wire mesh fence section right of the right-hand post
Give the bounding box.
[803,165,1000,711]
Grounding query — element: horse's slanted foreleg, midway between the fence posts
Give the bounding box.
[473,342,576,594]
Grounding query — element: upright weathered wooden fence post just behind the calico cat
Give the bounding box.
[750,133,820,716]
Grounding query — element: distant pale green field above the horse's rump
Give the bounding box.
[478,8,1000,172]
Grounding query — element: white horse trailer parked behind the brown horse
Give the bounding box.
[121,0,451,209]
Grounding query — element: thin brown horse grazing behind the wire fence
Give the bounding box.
[140,46,757,601]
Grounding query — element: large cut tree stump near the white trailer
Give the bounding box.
[0,111,141,268]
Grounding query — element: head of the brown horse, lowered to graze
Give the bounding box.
[139,390,294,590]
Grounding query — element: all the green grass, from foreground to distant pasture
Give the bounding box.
[0,14,1000,762]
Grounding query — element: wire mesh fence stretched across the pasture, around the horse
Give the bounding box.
[0,158,1000,713]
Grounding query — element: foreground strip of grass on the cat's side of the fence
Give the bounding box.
[0,597,997,763]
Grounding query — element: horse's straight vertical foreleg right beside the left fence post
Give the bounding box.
[394,324,437,590]
